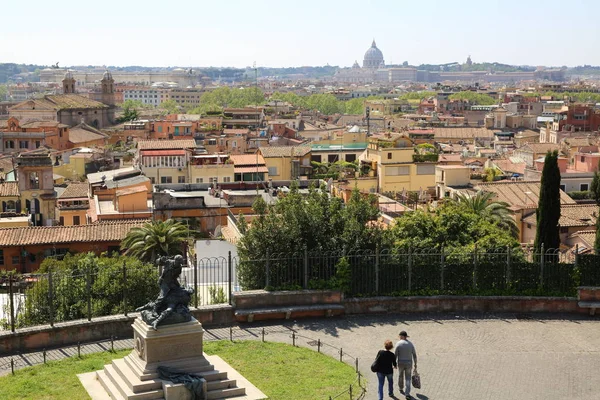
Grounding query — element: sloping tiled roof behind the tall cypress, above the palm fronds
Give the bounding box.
[476,181,576,208]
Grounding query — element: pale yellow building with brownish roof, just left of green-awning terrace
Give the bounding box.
[258,146,312,181]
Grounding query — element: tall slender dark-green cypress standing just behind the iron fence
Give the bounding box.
[533,150,560,251]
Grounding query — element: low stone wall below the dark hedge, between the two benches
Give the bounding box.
[343,296,587,314]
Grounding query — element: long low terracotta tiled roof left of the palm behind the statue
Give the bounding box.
[0,220,148,246]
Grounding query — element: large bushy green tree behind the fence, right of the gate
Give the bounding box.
[238,183,386,289]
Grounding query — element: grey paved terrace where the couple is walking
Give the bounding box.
[0,314,600,400]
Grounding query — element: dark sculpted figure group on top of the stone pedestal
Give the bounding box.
[136,255,194,330]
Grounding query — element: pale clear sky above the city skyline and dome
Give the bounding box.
[0,0,600,68]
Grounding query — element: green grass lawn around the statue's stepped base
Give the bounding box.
[0,341,355,400]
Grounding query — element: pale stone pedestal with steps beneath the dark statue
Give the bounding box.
[79,318,266,400]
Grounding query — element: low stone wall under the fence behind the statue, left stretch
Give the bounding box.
[0,305,235,355]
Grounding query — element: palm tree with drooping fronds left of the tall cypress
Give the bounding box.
[455,191,519,237]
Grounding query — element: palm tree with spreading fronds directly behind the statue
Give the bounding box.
[121,219,189,261]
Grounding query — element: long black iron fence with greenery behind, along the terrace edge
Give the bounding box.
[0,248,600,331]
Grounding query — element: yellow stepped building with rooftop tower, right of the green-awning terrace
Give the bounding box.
[360,133,437,193]
